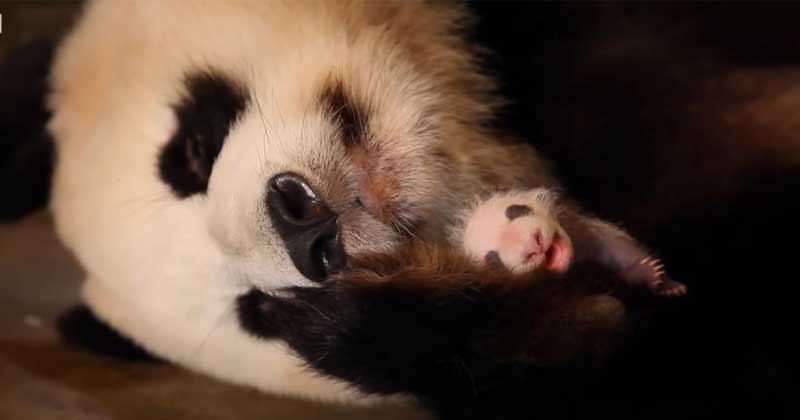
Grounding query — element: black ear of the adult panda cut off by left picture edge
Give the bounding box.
[0,41,55,222]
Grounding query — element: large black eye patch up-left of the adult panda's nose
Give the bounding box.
[159,71,248,198]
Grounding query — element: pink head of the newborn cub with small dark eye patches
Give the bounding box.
[462,189,573,273]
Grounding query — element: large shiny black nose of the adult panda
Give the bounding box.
[267,172,347,281]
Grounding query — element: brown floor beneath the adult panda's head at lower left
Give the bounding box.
[0,212,432,420]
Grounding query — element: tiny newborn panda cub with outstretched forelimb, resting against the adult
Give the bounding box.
[460,188,686,296]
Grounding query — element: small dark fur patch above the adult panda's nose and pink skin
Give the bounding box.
[320,81,368,146]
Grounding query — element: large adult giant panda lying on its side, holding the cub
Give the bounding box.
[1,0,800,418]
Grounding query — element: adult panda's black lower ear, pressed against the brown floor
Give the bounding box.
[56,305,160,362]
